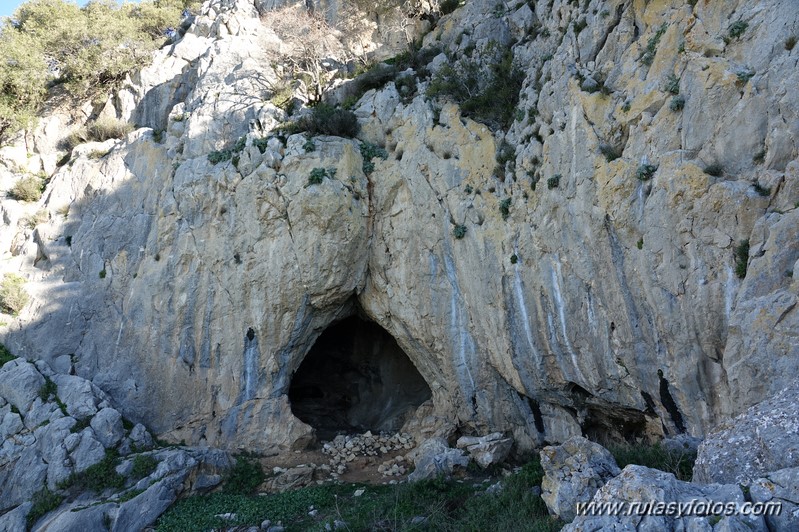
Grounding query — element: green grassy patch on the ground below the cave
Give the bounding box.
[156,459,563,531]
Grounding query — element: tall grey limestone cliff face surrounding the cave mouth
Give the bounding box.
[0,0,799,451]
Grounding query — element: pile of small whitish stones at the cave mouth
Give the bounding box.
[322,431,416,478]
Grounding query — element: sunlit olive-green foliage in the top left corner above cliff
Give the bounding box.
[0,0,197,141]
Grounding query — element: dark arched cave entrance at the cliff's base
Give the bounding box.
[289,316,432,440]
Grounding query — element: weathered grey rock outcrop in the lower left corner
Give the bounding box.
[0,359,232,532]
